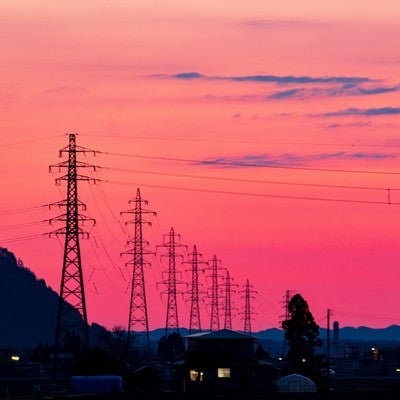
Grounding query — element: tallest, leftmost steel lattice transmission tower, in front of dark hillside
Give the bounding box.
[49,134,96,348]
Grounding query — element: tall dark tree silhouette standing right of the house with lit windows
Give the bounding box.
[282,294,322,379]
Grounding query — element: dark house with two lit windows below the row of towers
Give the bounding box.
[182,329,274,392]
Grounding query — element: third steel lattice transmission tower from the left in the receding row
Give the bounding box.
[157,228,186,337]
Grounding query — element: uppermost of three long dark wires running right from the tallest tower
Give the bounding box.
[97,151,400,175]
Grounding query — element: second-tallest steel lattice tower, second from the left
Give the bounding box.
[121,189,156,358]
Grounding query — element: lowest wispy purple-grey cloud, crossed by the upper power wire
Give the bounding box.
[198,151,398,168]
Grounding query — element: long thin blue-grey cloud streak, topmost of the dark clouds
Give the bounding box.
[169,72,374,85]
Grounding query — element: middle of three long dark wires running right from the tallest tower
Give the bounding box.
[99,167,400,191]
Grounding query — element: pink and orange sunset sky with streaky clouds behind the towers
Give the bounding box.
[0,0,400,331]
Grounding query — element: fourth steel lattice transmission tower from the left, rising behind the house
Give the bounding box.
[184,245,207,334]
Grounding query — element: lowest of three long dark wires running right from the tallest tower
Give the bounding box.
[101,180,400,205]
